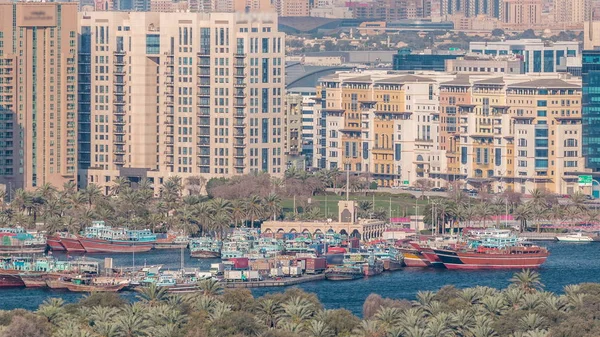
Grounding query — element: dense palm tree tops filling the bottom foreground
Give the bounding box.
[0,270,600,337]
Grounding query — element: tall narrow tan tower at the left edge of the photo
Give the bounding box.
[0,2,77,189]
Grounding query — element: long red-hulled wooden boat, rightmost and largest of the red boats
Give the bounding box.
[434,246,550,270]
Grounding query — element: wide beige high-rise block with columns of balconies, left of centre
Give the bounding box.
[79,12,285,191]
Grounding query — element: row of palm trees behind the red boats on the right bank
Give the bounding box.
[423,189,600,232]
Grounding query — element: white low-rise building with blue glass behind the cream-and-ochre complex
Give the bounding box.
[469,39,580,73]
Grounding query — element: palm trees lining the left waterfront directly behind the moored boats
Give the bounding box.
[0,177,282,236]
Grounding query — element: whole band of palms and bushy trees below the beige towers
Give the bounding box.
[0,169,367,236]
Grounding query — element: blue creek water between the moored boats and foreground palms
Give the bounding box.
[0,242,600,315]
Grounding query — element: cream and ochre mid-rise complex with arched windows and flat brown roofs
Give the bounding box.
[314,71,585,194]
